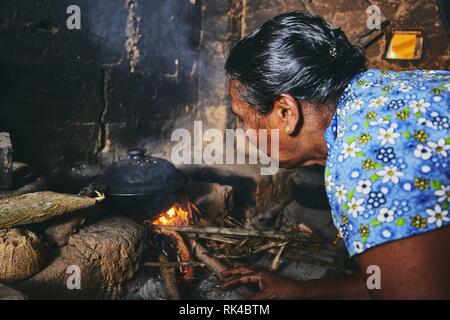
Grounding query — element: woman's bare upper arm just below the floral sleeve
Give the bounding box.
[358,226,450,299]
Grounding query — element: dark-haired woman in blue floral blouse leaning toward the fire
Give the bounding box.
[224,12,450,299]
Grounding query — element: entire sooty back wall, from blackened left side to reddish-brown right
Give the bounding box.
[0,0,450,171]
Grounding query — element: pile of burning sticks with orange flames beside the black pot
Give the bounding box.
[144,201,330,298]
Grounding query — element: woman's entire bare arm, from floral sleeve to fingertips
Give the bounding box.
[223,227,450,299]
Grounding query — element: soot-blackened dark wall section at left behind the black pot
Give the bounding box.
[0,0,201,169]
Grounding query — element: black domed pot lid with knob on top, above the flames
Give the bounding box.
[94,149,189,196]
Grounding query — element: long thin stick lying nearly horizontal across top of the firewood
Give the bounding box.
[155,225,314,242]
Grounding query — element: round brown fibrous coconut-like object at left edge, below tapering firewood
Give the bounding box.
[0,228,46,283]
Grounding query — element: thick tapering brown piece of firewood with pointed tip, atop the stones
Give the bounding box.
[0,191,104,229]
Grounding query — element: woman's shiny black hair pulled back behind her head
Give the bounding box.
[225,12,366,114]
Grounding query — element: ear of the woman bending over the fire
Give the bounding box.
[274,93,301,135]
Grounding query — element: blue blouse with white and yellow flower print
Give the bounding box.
[325,70,450,256]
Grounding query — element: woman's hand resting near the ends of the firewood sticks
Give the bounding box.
[222,266,302,300]
